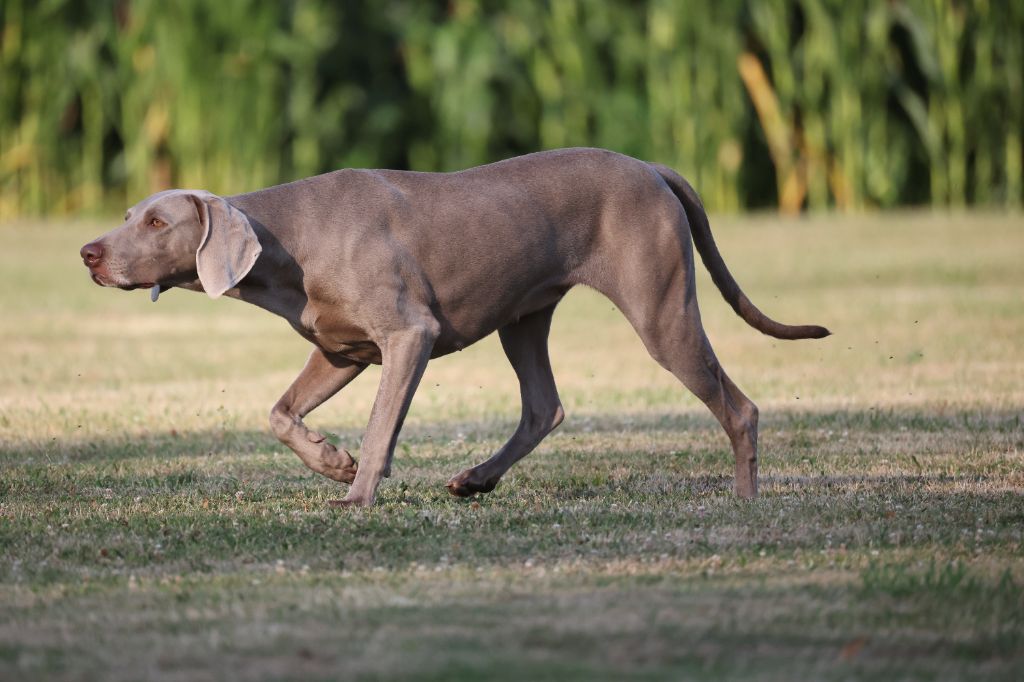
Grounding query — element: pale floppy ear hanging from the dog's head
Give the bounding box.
[191,191,263,298]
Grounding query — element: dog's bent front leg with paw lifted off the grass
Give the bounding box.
[270,348,367,483]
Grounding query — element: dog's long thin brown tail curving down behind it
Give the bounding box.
[651,164,831,339]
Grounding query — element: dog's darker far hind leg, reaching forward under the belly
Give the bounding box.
[447,305,565,497]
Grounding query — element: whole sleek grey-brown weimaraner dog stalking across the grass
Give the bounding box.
[81,148,828,506]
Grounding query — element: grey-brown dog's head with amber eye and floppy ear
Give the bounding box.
[80,189,262,300]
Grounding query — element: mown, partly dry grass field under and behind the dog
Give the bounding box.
[0,214,1024,681]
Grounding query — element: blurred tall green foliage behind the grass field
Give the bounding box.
[0,0,1024,218]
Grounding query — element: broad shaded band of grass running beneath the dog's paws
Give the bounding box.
[0,399,1020,582]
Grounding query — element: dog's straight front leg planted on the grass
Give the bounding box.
[331,327,437,507]
